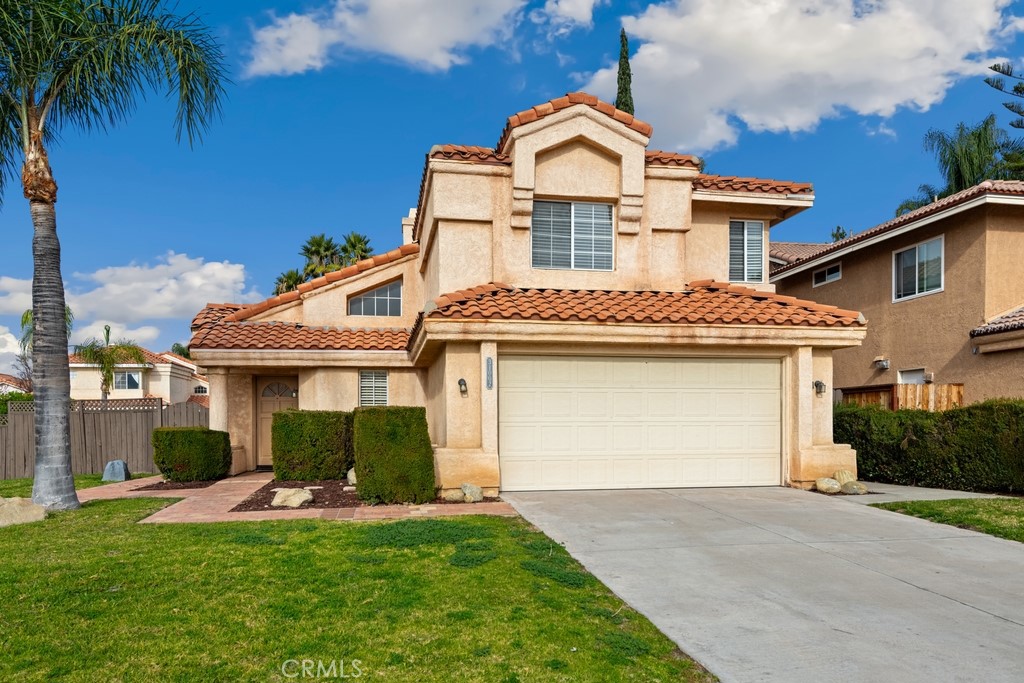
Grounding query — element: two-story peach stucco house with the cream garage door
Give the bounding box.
[190,93,864,490]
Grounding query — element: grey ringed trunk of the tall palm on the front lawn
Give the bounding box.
[22,139,81,510]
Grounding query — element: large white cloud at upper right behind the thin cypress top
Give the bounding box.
[587,0,1022,152]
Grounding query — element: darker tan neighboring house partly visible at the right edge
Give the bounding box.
[771,180,1024,402]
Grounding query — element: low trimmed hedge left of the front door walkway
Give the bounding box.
[153,427,231,481]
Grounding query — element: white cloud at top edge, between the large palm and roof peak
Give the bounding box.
[245,0,525,77]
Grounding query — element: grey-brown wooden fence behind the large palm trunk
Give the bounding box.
[0,398,210,479]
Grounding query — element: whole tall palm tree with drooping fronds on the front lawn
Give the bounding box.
[0,0,224,509]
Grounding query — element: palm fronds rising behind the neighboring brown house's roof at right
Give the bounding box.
[896,114,1024,216]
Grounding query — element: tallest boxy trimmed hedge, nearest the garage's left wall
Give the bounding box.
[352,405,437,503]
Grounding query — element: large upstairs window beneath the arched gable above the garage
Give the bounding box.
[530,201,613,270]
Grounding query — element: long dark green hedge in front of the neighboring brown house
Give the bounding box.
[833,399,1024,493]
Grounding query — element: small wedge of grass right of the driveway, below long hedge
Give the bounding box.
[874,498,1024,543]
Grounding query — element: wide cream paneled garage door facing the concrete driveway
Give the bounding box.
[498,356,782,490]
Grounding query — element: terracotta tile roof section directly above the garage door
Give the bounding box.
[427,281,863,327]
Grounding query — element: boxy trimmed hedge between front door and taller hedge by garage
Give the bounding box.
[270,411,355,481]
